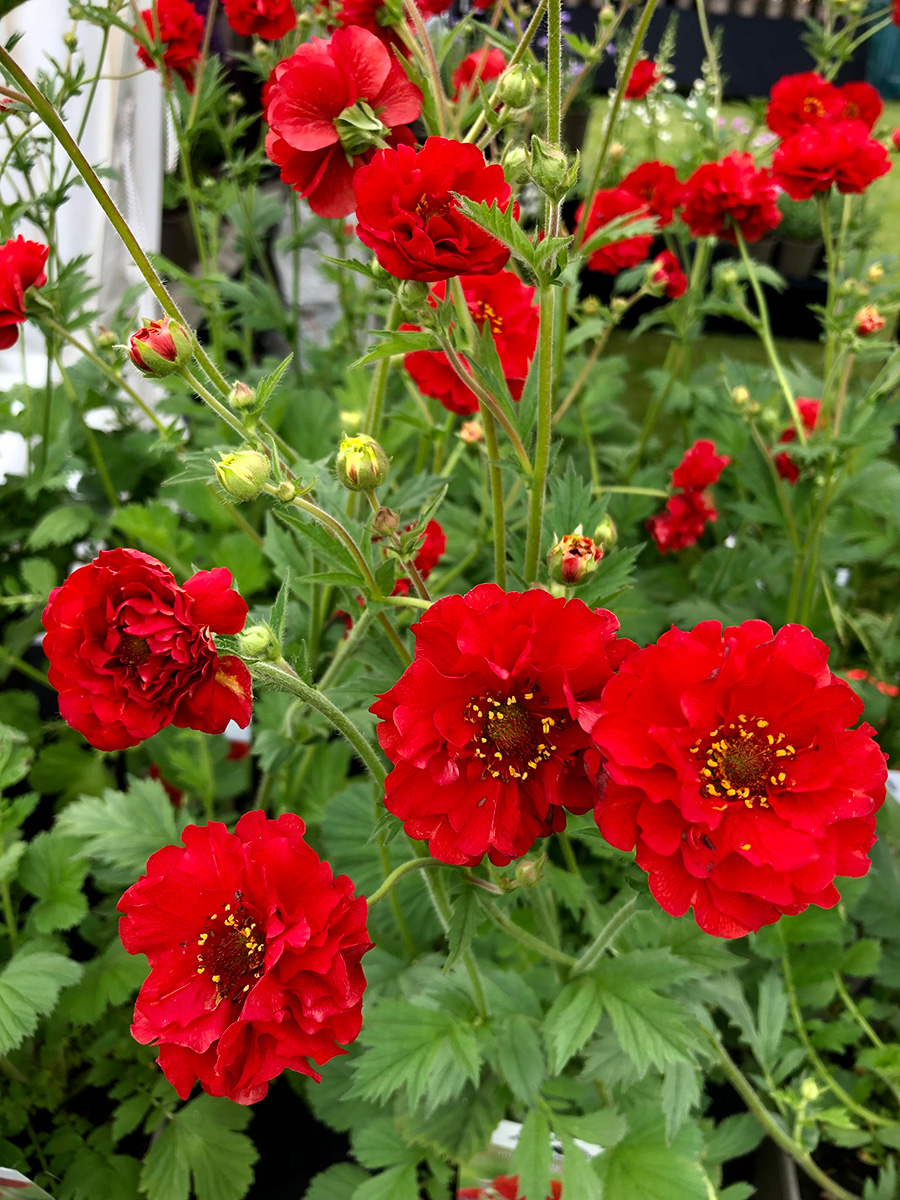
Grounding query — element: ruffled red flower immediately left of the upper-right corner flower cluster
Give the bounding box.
[682,151,781,245]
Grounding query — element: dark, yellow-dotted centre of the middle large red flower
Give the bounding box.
[466,691,563,784]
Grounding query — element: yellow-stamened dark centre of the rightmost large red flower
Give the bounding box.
[690,713,796,811]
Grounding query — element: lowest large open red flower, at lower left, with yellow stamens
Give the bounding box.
[119,812,372,1104]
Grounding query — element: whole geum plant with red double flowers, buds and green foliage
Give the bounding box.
[0,0,900,1200]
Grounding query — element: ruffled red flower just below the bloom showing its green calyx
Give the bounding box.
[353,138,511,283]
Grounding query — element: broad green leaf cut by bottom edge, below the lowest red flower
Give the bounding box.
[140,1096,259,1200]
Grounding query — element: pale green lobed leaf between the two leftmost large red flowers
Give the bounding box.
[56,779,184,880]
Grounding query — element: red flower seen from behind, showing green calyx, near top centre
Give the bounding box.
[265,28,422,217]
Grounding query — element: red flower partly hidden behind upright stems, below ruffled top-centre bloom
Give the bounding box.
[401,271,540,416]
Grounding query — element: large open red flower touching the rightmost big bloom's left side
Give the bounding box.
[371,583,634,865]
